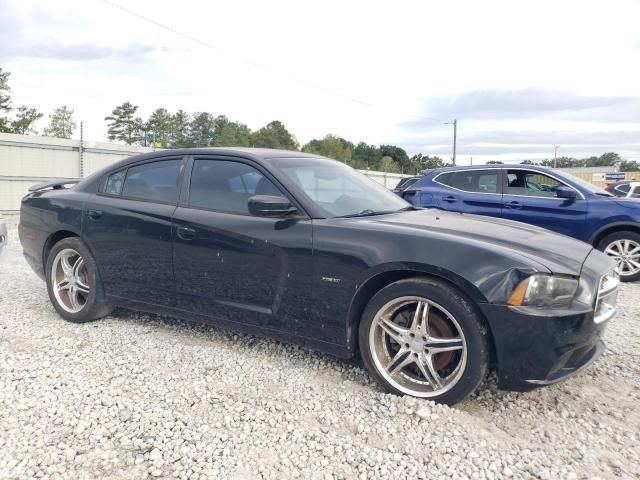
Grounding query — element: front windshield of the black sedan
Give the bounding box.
[271,158,411,217]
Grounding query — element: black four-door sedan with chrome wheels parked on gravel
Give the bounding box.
[19,149,618,404]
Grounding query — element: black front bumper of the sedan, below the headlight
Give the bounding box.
[482,304,608,391]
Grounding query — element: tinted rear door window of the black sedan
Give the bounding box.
[122,159,182,203]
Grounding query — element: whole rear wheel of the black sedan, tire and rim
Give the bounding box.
[46,237,111,323]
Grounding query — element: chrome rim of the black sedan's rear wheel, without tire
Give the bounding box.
[51,248,90,313]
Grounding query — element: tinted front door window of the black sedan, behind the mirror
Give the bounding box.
[189,159,282,215]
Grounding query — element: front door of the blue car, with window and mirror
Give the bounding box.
[502,168,587,238]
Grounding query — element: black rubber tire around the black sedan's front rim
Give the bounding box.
[358,278,490,405]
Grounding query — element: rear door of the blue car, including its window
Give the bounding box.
[434,168,502,217]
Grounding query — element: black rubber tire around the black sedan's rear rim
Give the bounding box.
[45,237,113,323]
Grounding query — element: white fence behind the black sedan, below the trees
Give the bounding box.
[0,133,407,214]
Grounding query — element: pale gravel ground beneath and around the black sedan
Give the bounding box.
[0,218,640,479]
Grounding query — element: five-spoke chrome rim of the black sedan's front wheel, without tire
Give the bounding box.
[369,297,467,398]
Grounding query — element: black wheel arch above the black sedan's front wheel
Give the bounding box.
[347,265,495,362]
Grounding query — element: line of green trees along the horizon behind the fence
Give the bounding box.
[0,68,640,175]
